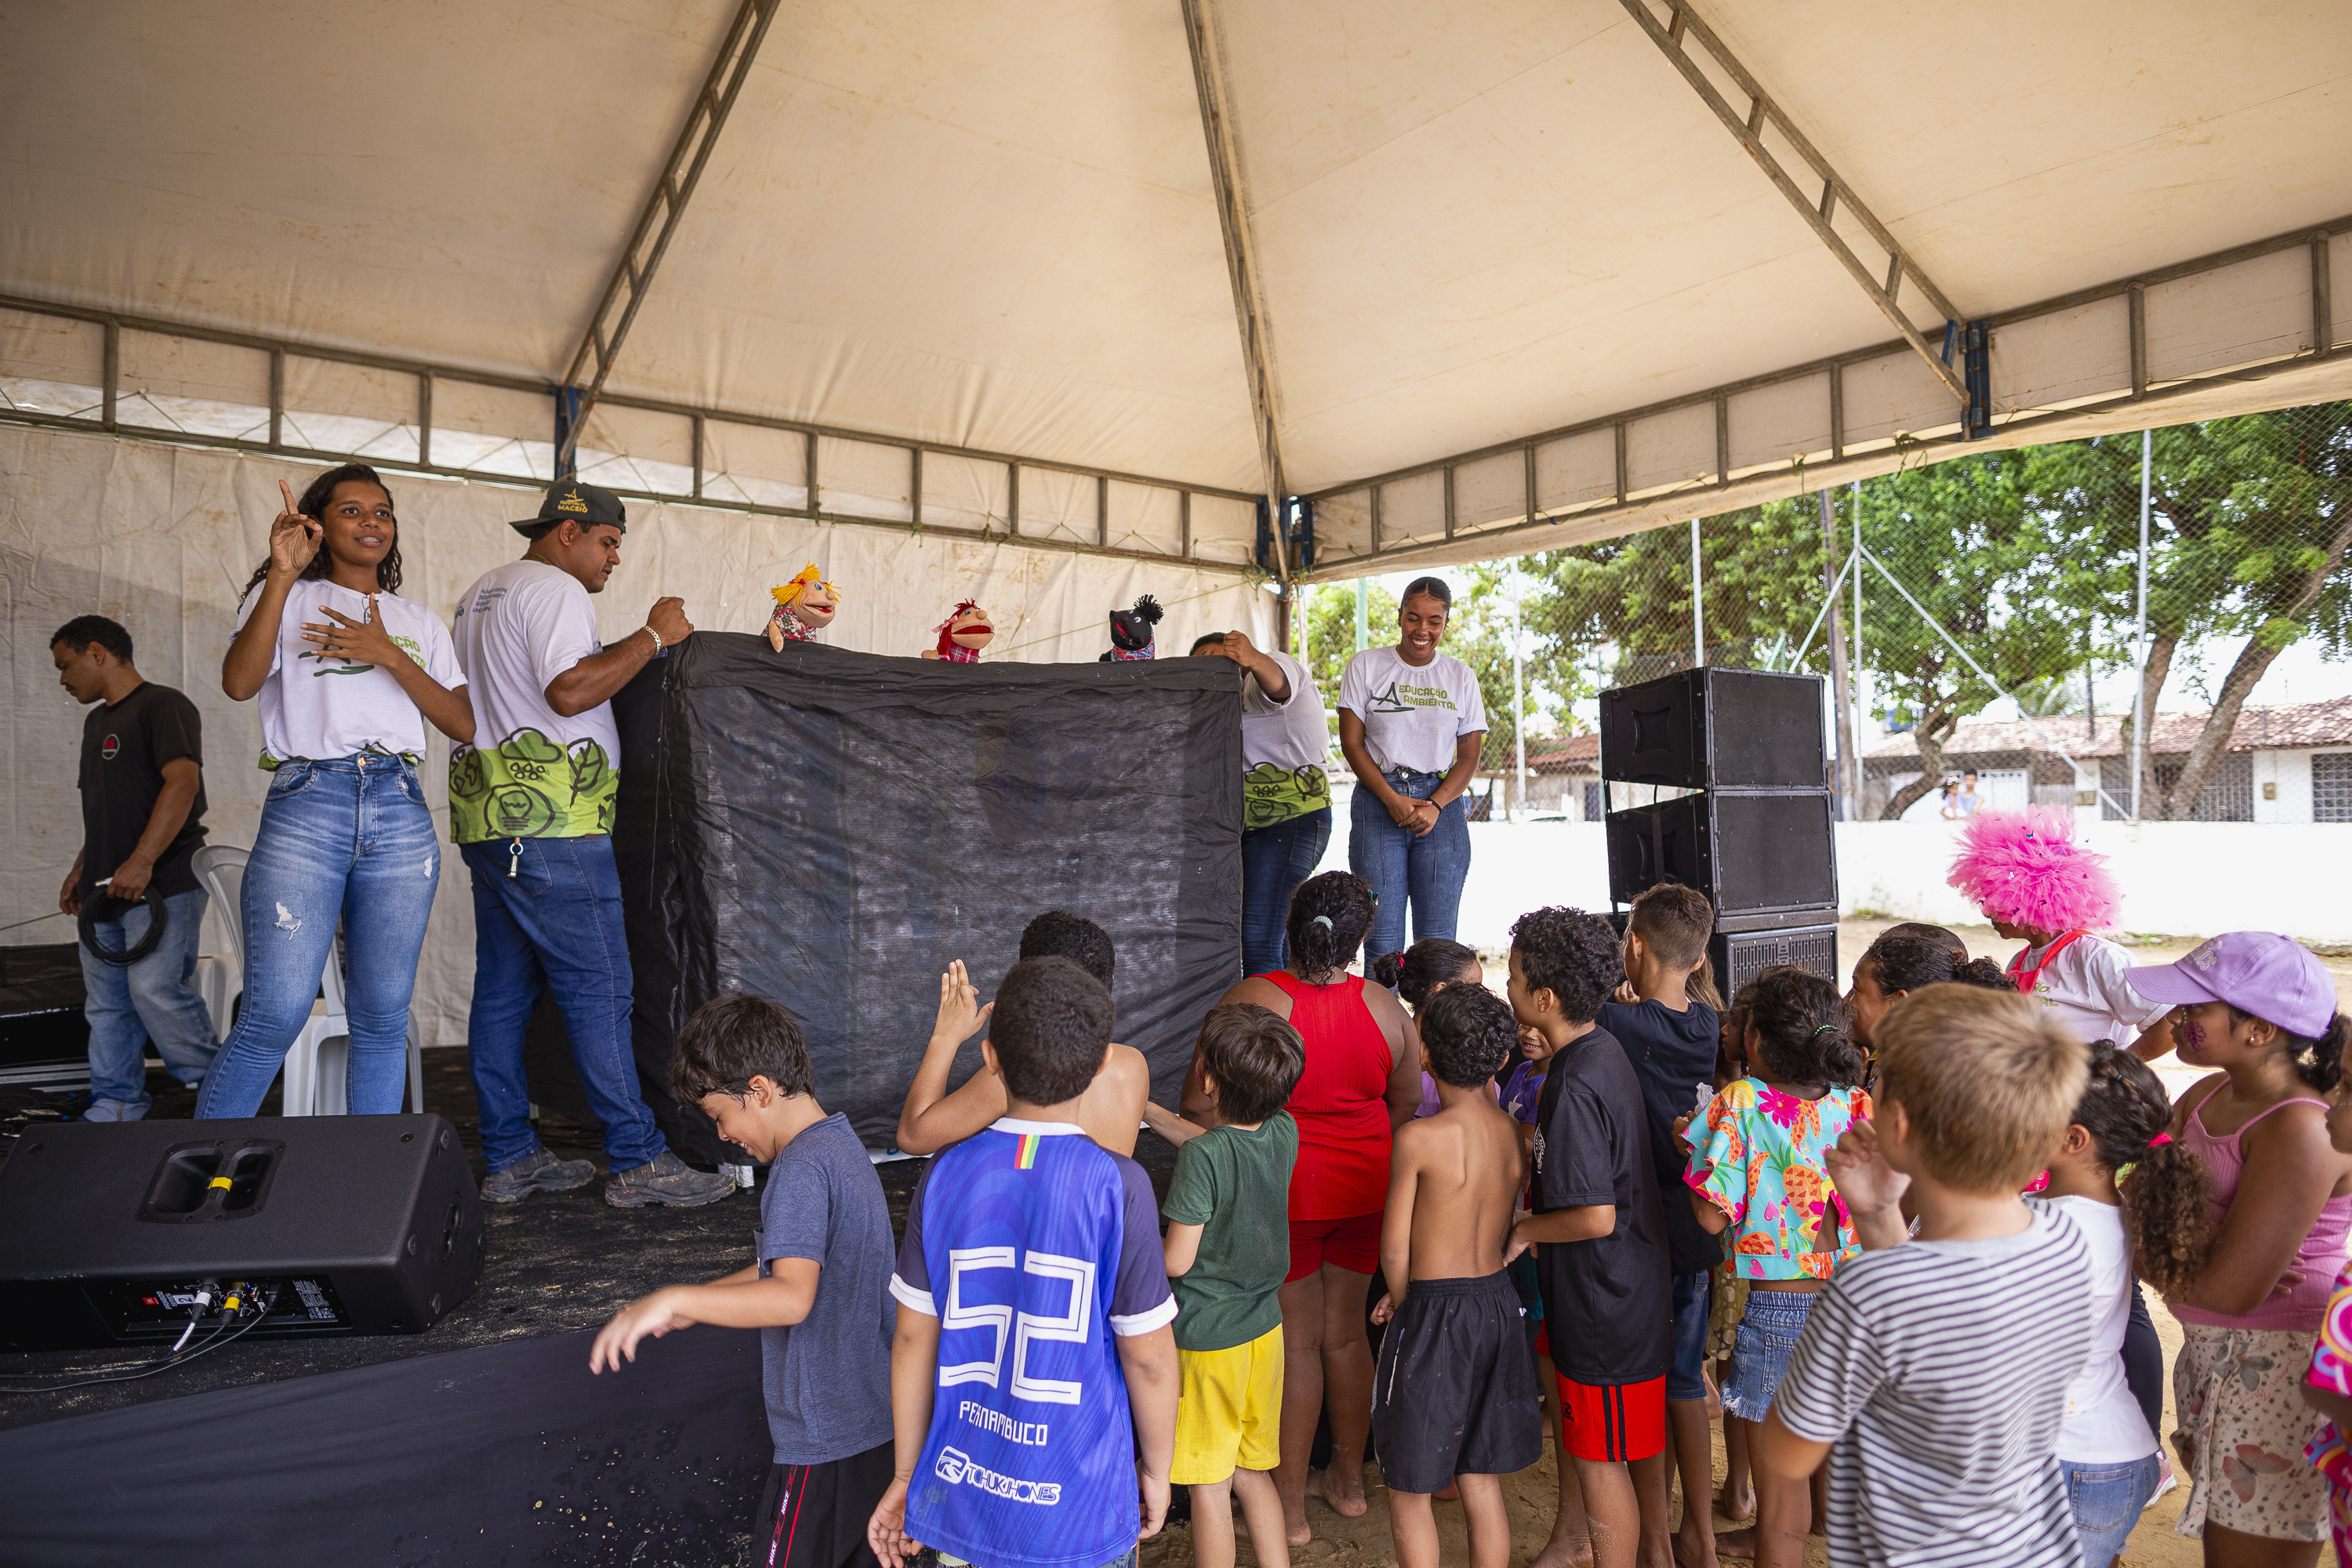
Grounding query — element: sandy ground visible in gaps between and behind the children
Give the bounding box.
[1141,919,2314,1568]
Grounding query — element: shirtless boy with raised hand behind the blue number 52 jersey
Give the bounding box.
[898,909,1152,1159]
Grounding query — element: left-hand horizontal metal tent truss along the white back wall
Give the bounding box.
[0,294,1258,576]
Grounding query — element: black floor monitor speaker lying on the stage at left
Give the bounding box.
[0,1114,482,1349]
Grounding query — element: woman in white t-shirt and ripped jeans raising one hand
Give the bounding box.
[195,463,473,1116]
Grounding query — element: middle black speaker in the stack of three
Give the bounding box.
[1606,789,1837,916]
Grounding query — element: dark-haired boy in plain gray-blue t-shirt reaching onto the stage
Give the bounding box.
[588,994,896,1568]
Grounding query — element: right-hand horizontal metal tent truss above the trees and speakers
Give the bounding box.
[1301,208,2352,583]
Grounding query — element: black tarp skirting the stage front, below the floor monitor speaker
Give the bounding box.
[0,1316,769,1568]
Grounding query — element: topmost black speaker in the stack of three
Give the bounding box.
[1602,666,1830,789]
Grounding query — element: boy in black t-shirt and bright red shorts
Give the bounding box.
[1510,907,1675,1568]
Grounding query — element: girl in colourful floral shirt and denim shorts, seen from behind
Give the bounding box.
[1684,964,1870,1568]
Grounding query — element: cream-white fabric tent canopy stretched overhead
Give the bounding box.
[0,0,2352,576]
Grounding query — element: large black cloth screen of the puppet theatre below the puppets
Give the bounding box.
[588,633,1242,1161]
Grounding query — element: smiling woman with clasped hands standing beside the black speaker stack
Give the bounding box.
[1338,576,1486,952]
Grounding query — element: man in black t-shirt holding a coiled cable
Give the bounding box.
[49,616,219,1121]
